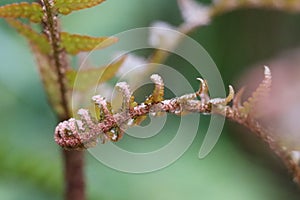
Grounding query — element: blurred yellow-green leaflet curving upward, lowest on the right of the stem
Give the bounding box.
[66,56,126,90]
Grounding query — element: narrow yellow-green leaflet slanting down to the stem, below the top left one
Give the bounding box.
[6,19,51,54]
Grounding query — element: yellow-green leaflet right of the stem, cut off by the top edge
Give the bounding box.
[54,0,104,15]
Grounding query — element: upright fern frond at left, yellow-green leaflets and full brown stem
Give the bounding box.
[0,0,124,200]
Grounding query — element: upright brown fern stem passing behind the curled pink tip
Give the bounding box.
[40,0,85,200]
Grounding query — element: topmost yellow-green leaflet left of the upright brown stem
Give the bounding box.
[0,2,43,23]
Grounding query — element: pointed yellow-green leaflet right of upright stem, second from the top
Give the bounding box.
[61,32,118,55]
